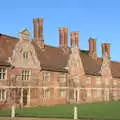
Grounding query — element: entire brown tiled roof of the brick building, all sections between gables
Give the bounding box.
[0,34,120,78]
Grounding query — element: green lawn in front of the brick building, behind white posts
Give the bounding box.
[0,102,120,120]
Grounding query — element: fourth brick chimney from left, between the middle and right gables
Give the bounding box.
[88,38,97,58]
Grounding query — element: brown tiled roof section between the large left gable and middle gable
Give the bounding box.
[32,41,69,71]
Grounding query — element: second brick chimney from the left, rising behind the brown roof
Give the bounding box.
[59,28,68,48]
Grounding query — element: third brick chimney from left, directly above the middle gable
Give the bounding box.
[71,32,79,47]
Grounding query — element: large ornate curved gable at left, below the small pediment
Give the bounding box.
[9,40,40,68]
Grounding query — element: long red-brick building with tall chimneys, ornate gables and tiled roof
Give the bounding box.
[0,18,120,107]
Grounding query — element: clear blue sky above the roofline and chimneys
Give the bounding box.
[0,0,120,61]
